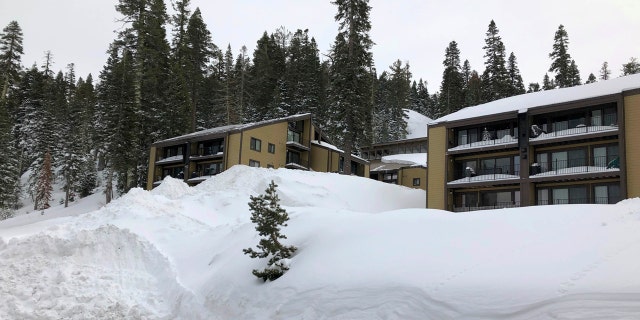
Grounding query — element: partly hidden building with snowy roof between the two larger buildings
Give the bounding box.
[362,137,427,190]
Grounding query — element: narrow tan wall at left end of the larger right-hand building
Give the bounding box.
[427,126,449,210]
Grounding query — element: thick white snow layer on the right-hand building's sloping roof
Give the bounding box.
[429,74,640,125]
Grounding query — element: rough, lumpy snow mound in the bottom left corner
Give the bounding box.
[0,226,201,319]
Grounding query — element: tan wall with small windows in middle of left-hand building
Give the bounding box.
[240,121,288,168]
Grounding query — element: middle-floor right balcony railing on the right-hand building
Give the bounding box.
[530,156,620,176]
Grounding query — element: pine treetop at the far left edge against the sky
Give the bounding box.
[0,21,23,107]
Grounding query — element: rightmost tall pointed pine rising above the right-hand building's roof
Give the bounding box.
[545,25,580,90]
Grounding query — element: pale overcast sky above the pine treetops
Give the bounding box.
[0,0,640,93]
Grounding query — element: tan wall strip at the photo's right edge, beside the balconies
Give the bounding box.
[624,93,640,198]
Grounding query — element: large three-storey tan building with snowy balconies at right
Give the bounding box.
[427,74,640,211]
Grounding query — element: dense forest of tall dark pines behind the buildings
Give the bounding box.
[0,0,640,219]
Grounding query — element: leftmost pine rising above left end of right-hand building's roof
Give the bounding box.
[437,41,464,116]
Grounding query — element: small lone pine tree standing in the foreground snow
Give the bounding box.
[242,180,297,281]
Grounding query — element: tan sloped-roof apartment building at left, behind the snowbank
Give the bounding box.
[147,114,369,190]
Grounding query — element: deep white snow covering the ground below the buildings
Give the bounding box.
[0,166,640,319]
